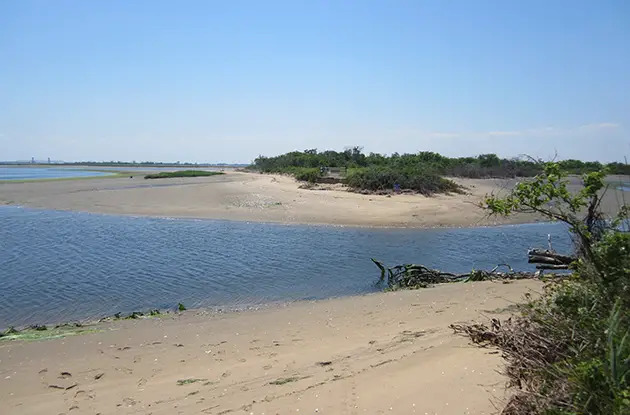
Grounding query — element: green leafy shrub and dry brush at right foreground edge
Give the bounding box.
[452,163,630,415]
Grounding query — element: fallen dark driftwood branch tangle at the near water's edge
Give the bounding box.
[372,258,556,289]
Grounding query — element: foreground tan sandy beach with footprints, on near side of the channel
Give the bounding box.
[0,281,541,415]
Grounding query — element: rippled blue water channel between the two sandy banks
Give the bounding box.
[0,206,569,327]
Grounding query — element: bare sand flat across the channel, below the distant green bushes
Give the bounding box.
[0,172,556,228]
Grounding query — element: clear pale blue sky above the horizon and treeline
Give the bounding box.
[0,0,630,163]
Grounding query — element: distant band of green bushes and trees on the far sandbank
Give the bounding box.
[248,147,630,195]
